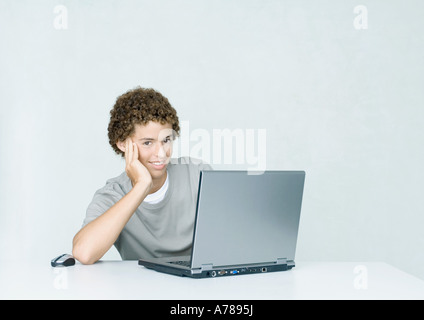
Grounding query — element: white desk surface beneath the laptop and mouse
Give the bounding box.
[0,261,424,300]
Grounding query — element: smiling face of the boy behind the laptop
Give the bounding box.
[131,121,174,179]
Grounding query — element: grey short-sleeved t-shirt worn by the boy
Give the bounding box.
[83,157,212,260]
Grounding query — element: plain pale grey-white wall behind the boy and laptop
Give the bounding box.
[0,0,424,285]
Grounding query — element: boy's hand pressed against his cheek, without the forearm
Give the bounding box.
[125,138,152,190]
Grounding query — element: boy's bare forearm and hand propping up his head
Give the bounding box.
[72,140,152,264]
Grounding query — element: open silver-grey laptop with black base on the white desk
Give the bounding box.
[138,170,305,278]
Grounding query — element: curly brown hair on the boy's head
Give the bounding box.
[108,87,180,156]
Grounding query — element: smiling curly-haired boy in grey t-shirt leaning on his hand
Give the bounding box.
[72,87,212,264]
